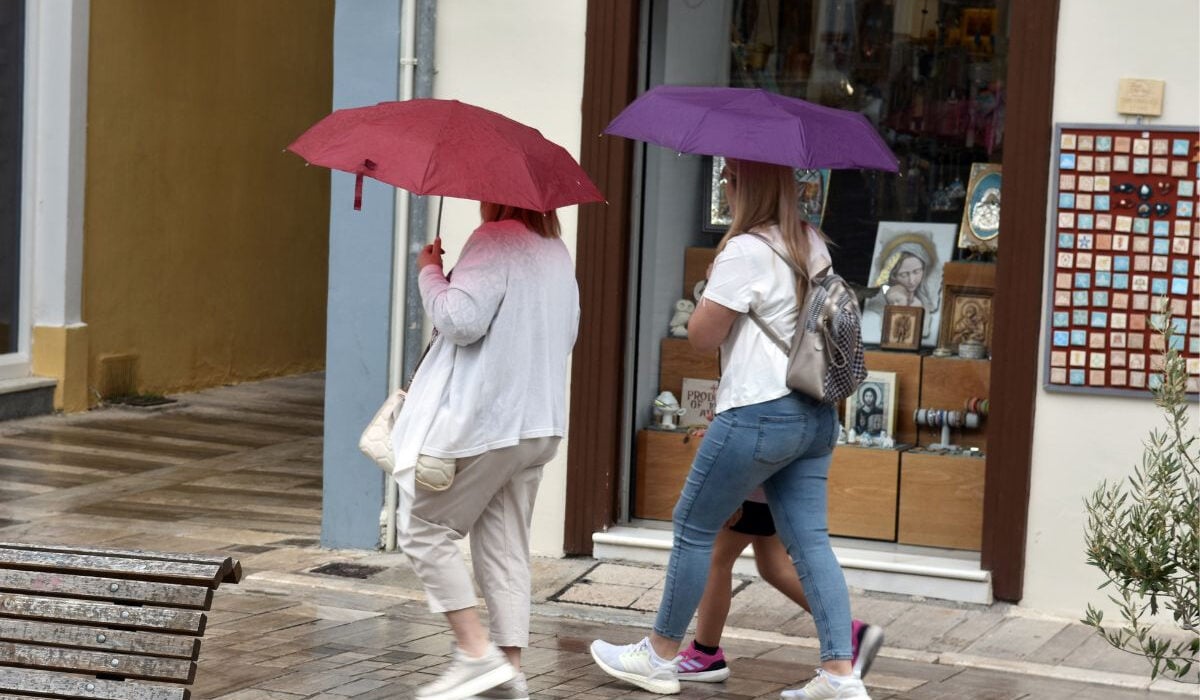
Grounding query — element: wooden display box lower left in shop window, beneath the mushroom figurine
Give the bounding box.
[634,430,701,520]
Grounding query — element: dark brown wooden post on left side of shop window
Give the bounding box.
[563,0,640,555]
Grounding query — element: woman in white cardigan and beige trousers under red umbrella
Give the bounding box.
[394,203,580,700]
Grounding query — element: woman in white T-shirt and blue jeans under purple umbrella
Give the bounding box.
[592,158,870,700]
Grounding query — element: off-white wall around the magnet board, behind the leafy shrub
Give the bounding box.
[1021,0,1200,617]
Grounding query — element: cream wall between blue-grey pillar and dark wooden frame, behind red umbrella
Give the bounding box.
[430,0,587,556]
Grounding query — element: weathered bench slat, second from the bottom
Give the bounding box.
[0,641,196,683]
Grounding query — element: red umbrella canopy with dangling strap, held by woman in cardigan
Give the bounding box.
[288,98,605,211]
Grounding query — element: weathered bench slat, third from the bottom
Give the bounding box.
[0,617,200,659]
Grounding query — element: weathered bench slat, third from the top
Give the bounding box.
[0,569,212,610]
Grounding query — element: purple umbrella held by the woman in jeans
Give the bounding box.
[605,85,899,172]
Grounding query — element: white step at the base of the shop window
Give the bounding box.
[592,522,992,605]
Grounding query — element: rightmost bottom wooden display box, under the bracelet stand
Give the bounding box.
[896,451,985,550]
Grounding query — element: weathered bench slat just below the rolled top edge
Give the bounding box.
[0,548,224,588]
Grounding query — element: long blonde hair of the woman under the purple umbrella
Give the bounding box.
[716,158,828,300]
